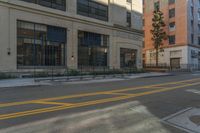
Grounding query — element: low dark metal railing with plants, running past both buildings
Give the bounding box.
[0,64,200,81]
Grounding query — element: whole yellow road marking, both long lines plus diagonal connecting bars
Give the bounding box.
[0,79,200,120]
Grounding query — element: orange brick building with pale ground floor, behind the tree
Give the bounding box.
[143,0,200,68]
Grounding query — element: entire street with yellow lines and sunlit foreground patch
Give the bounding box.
[0,73,200,133]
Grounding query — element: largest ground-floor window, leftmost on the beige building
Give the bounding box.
[17,21,67,67]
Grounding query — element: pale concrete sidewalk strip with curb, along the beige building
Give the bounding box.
[0,72,172,88]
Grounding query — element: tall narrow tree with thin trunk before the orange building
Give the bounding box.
[151,9,167,67]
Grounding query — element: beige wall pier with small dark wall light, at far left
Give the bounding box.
[0,6,17,71]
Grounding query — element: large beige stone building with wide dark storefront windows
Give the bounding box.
[0,0,143,71]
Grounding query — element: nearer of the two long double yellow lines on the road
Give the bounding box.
[0,82,200,120]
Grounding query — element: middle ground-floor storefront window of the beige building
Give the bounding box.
[78,31,109,67]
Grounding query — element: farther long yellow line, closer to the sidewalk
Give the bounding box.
[0,78,200,107]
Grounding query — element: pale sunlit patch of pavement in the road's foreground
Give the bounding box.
[0,101,184,133]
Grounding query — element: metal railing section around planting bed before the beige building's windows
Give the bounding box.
[30,66,144,81]
